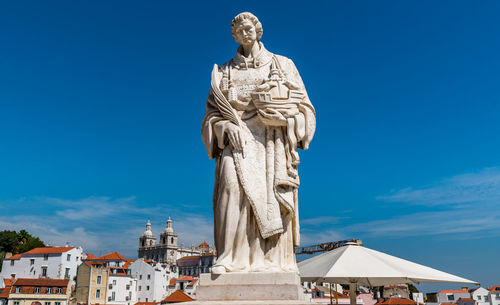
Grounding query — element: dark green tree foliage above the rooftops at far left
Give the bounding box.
[0,230,45,271]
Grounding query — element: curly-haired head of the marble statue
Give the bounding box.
[231,12,263,44]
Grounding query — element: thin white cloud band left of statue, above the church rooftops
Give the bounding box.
[0,196,213,258]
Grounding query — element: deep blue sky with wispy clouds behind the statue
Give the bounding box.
[0,1,500,289]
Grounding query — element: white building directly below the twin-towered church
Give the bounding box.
[129,258,177,302]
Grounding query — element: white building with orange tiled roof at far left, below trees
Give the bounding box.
[0,247,84,284]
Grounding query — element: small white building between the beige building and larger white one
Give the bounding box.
[106,266,137,305]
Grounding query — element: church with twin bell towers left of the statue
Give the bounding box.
[138,217,213,265]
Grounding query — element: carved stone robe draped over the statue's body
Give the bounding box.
[201,44,316,272]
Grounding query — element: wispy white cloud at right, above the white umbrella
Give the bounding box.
[345,167,500,238]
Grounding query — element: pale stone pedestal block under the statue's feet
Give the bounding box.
[186,272,311,305]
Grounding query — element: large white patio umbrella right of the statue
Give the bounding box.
[298,243,478,305]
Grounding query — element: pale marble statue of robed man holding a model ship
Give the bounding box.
[201,13,316,275]
